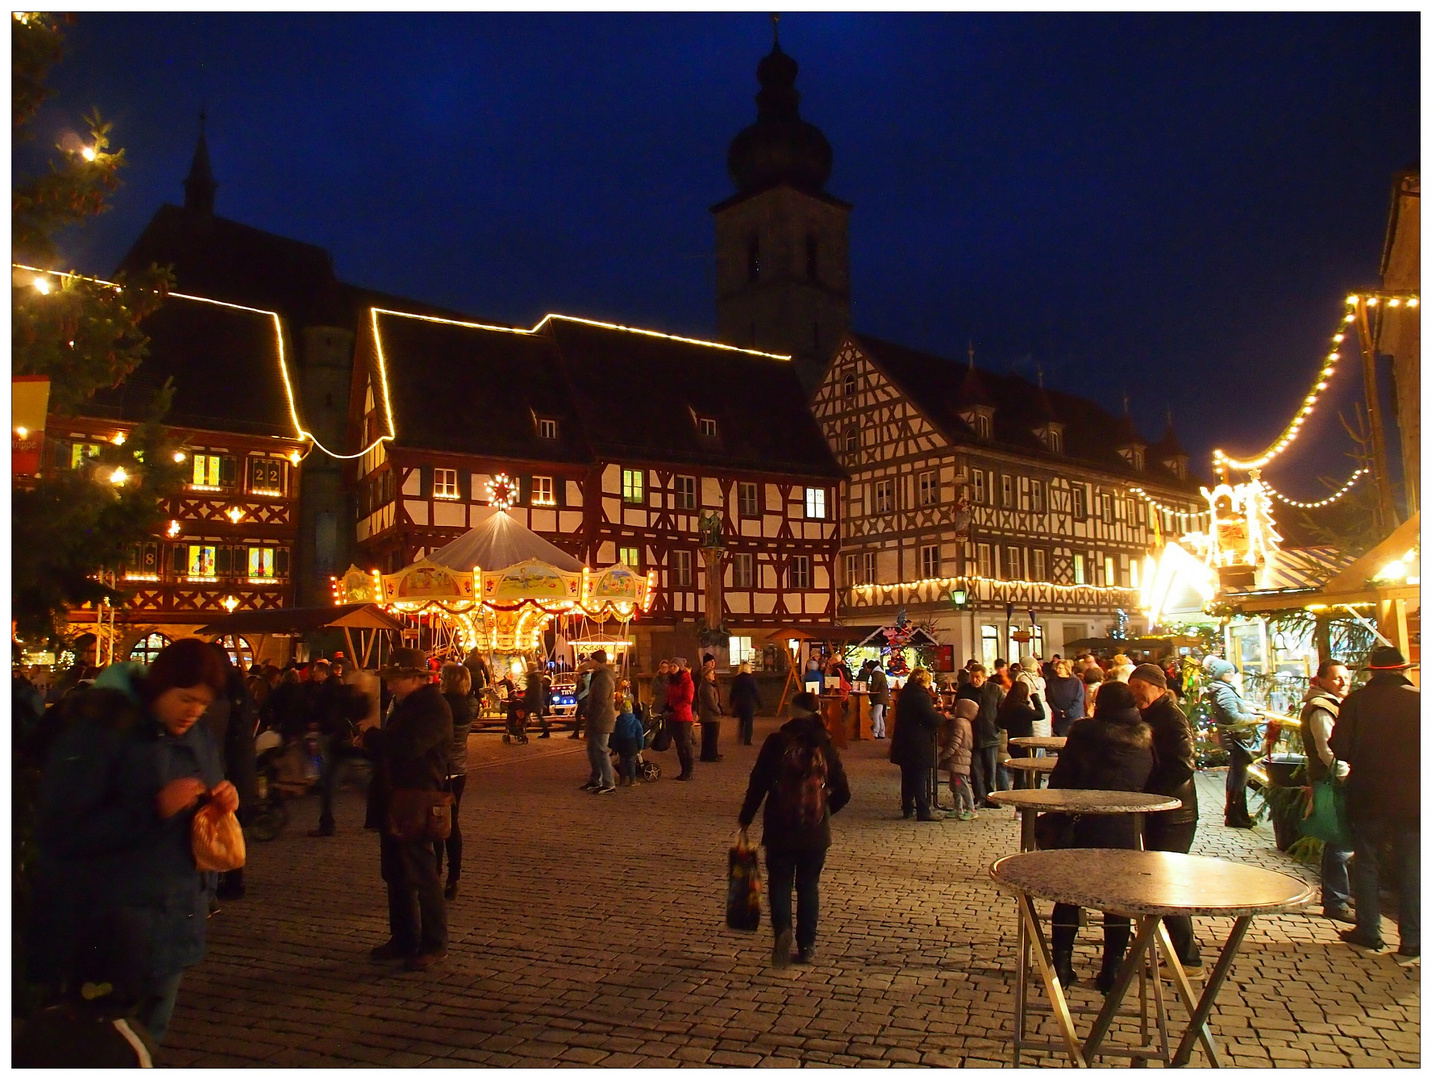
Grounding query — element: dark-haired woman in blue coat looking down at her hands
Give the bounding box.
[27,637,231,1043]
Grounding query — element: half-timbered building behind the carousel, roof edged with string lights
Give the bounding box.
[352,308,842,662]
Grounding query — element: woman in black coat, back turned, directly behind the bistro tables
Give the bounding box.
[1048,682,1154,994]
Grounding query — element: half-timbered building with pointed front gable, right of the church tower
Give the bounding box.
[812,334,1200,662]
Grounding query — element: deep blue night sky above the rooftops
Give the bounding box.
[27,13,1419,497]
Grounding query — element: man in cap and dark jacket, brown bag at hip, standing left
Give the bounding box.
[368,649,453,971]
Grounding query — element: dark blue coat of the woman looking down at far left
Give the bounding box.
[26,665,223,980]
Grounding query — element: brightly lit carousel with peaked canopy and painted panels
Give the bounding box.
[334,492,652,678]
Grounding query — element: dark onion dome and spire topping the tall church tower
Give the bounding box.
[726,16,835,195]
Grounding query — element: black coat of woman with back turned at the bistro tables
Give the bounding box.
[1050,709,1154,848]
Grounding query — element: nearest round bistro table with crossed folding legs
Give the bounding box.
[990,848,1313,1067]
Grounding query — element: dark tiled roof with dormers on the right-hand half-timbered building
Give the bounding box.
[851,334,1197,493]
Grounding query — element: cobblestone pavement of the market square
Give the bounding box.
[165,718,1421,1067]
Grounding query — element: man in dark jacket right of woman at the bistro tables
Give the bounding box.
[1128,663,1203,975]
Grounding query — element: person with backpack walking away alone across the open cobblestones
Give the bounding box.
[737,692,851,967]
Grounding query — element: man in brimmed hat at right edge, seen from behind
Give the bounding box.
[1327,646,1422,960]
